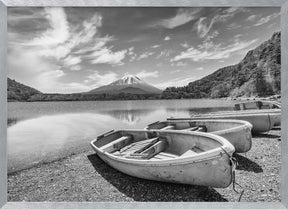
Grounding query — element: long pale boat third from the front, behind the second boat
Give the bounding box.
[168,110,281,133]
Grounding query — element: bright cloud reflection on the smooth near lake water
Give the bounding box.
[7,110,170,173]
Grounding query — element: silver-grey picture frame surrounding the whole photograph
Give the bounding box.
[0,0,288,209]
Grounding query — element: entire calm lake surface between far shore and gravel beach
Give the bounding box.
[7,99,233,173]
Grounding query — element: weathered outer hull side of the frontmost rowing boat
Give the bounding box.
[97,150,232,188]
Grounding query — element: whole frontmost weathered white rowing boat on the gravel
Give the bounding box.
[91,130,235,188]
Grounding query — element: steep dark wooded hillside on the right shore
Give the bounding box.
[162,32,281,99]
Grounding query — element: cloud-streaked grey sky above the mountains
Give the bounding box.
[7,7,280,93]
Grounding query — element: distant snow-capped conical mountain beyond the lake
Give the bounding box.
[87,75,162,94]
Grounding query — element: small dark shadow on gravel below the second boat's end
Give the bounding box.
[233,153,263,173]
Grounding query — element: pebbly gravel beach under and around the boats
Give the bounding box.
[8,128,281,202]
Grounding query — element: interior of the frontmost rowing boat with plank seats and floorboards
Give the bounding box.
[94,131,222,160]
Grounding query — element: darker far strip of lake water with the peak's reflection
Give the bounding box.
[7,99,231,126]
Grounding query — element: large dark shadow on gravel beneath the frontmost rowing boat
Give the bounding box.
[87,154,227,202]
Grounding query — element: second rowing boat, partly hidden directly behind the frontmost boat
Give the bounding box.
[146,120,252,153]
